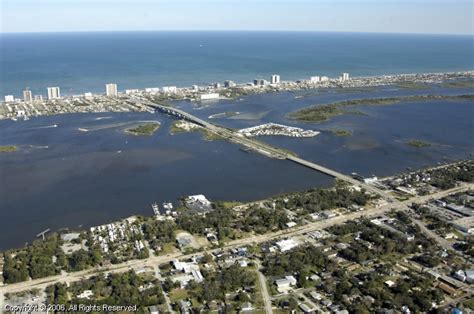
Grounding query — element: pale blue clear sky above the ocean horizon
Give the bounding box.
[0,0,474,35]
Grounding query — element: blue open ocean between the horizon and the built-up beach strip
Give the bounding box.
[0,32,474,96]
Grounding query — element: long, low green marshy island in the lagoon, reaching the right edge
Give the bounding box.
[288,95,474,122]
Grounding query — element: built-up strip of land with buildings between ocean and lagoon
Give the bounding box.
[0,70,474,121]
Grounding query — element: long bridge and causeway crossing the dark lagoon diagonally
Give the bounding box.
[129,97,394,201]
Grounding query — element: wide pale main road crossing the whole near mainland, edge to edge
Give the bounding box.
[0,184,474,309]
